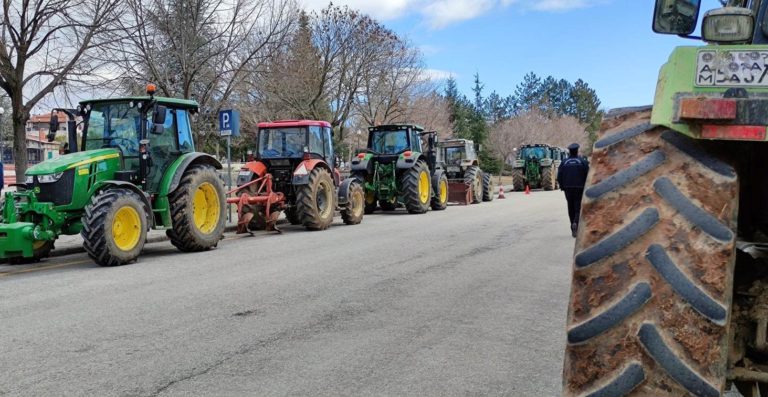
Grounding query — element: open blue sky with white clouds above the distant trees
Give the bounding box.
[304,0,720,109]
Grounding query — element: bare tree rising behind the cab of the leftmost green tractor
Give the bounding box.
[111,0,296,148]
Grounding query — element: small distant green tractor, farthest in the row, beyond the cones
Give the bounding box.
[512,144,560,192]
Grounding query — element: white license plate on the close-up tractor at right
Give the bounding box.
[696,50,768,87]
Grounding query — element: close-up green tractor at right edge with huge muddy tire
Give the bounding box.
[563,0,768,397]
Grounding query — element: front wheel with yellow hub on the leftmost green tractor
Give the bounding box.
[80,188,150,266]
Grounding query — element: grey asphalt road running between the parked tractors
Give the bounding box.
[0,192,573,396]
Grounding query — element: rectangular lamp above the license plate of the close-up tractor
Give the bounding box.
[701,7,755,43]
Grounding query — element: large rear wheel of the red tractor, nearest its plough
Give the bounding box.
[296,167,336,230]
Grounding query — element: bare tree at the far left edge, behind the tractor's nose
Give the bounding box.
[0,0,120,180]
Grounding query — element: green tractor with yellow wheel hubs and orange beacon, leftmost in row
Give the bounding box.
[0,86,225,266]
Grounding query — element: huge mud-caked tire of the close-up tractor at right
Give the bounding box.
[563,120,739,397]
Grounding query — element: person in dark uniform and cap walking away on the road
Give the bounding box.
[557,143,589,237]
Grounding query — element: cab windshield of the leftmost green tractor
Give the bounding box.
[85,103,141,156]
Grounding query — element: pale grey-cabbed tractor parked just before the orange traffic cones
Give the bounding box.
[437,139,496,204]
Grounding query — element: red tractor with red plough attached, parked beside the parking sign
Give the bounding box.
[227,120,365,233]
